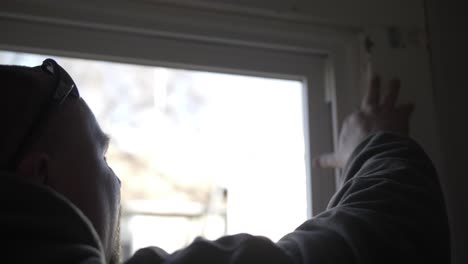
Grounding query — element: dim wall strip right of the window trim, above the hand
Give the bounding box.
[272,0,443,169]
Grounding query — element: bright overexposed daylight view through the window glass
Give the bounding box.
[0,51,307,256]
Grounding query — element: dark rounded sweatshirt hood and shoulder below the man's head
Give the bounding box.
[0,172,105,264]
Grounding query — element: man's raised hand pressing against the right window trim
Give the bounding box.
[313,77,414,168]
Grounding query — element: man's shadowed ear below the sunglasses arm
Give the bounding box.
[16,152,50,184]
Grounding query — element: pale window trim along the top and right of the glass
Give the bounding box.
[0,0,362,217]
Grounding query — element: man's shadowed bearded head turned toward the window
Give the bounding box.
[0,60,120,261]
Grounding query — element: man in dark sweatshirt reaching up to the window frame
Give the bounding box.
[0,60,450,264]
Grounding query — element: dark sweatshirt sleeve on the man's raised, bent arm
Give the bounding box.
[124,133,450,264]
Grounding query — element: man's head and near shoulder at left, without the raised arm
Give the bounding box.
[0,60,120,263]
